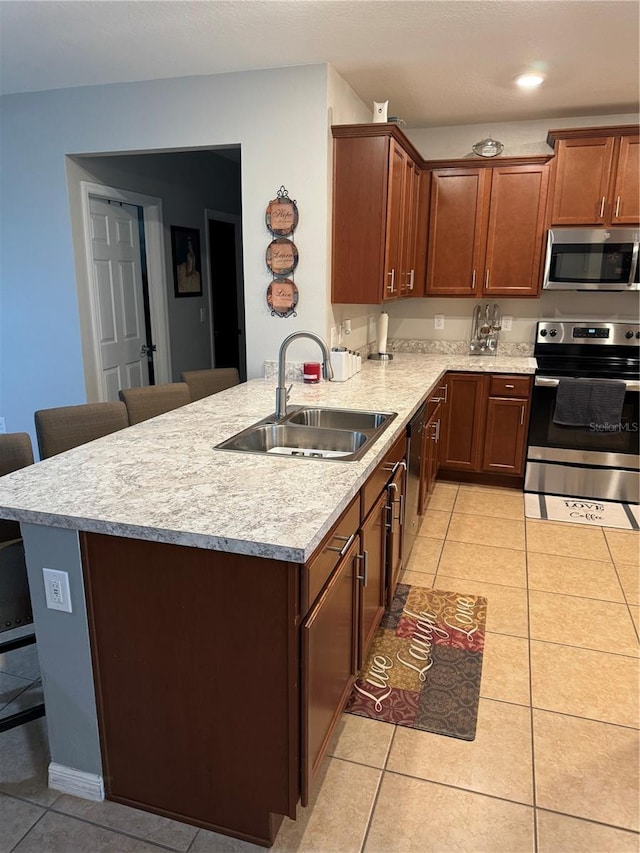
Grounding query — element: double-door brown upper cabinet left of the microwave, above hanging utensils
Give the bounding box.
[426,158,548,297]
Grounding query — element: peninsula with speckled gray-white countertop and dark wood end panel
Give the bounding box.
[0,354,535,845]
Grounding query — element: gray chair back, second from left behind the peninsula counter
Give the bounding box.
[34,400,129,459]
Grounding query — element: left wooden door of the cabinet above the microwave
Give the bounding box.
[551,136,614,225]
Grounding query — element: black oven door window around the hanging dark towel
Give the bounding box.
[529,387,640,454]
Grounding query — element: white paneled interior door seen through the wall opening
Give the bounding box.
[89,196,149,400]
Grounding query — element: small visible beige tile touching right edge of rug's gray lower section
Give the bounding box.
[480,633,531,707]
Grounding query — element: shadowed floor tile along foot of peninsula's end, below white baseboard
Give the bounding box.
[54,794,198,850]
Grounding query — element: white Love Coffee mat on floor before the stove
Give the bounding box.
[524,493,640,530]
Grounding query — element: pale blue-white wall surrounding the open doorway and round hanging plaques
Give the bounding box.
[0,65,336,442]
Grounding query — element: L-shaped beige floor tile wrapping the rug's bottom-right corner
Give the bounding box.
[387,699,533,804]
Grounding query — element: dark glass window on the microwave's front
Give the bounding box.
[549,243,633,285]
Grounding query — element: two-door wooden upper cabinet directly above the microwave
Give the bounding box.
[547,126,640,226]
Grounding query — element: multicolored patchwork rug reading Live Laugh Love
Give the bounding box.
[345,584,487,740]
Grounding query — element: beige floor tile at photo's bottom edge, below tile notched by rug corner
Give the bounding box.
[364,773,534,853]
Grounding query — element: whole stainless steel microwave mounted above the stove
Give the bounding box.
[542,228,640,290]
